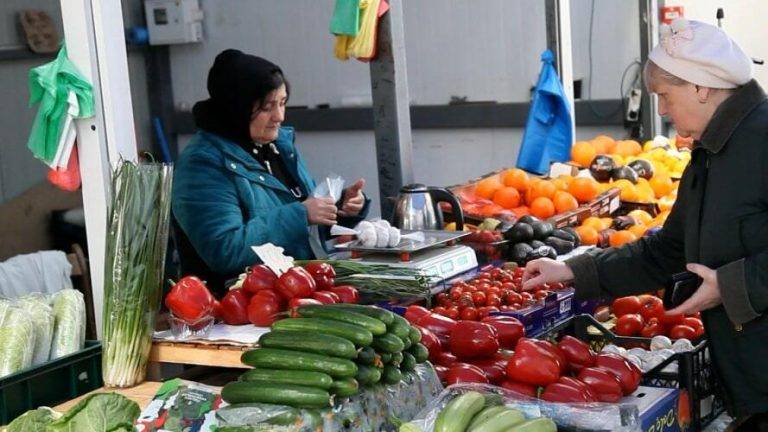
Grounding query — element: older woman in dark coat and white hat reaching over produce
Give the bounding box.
[524,20,768,430]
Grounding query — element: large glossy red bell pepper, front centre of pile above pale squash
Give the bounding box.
[507,338,560,386]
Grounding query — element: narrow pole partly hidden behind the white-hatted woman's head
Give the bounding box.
[640,0,667,139]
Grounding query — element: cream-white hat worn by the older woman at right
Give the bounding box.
[648,18,752,88]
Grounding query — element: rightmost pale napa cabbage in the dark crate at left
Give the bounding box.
[50,289,85,360]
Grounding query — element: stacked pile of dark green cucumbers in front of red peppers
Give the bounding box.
[221,304,429,408]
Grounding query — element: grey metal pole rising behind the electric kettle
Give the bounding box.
[370,0,413,219]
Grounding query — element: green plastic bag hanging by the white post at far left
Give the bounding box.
[27,46,93,165]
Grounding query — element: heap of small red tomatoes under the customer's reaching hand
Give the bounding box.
[432,267,565,321]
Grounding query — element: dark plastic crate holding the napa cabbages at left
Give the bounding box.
[0,341,103,425]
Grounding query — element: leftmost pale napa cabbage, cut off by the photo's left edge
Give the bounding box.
[0,306,35,377]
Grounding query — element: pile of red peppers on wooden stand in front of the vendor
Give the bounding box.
[165,262,360,327]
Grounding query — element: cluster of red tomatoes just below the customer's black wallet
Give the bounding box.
[611,294,704,340]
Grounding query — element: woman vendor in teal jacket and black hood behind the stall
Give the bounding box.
[172,49,370,291]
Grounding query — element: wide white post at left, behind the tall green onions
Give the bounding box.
[61,0,137,335]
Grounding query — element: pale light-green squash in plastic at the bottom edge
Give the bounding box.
[400,391,557,432]
